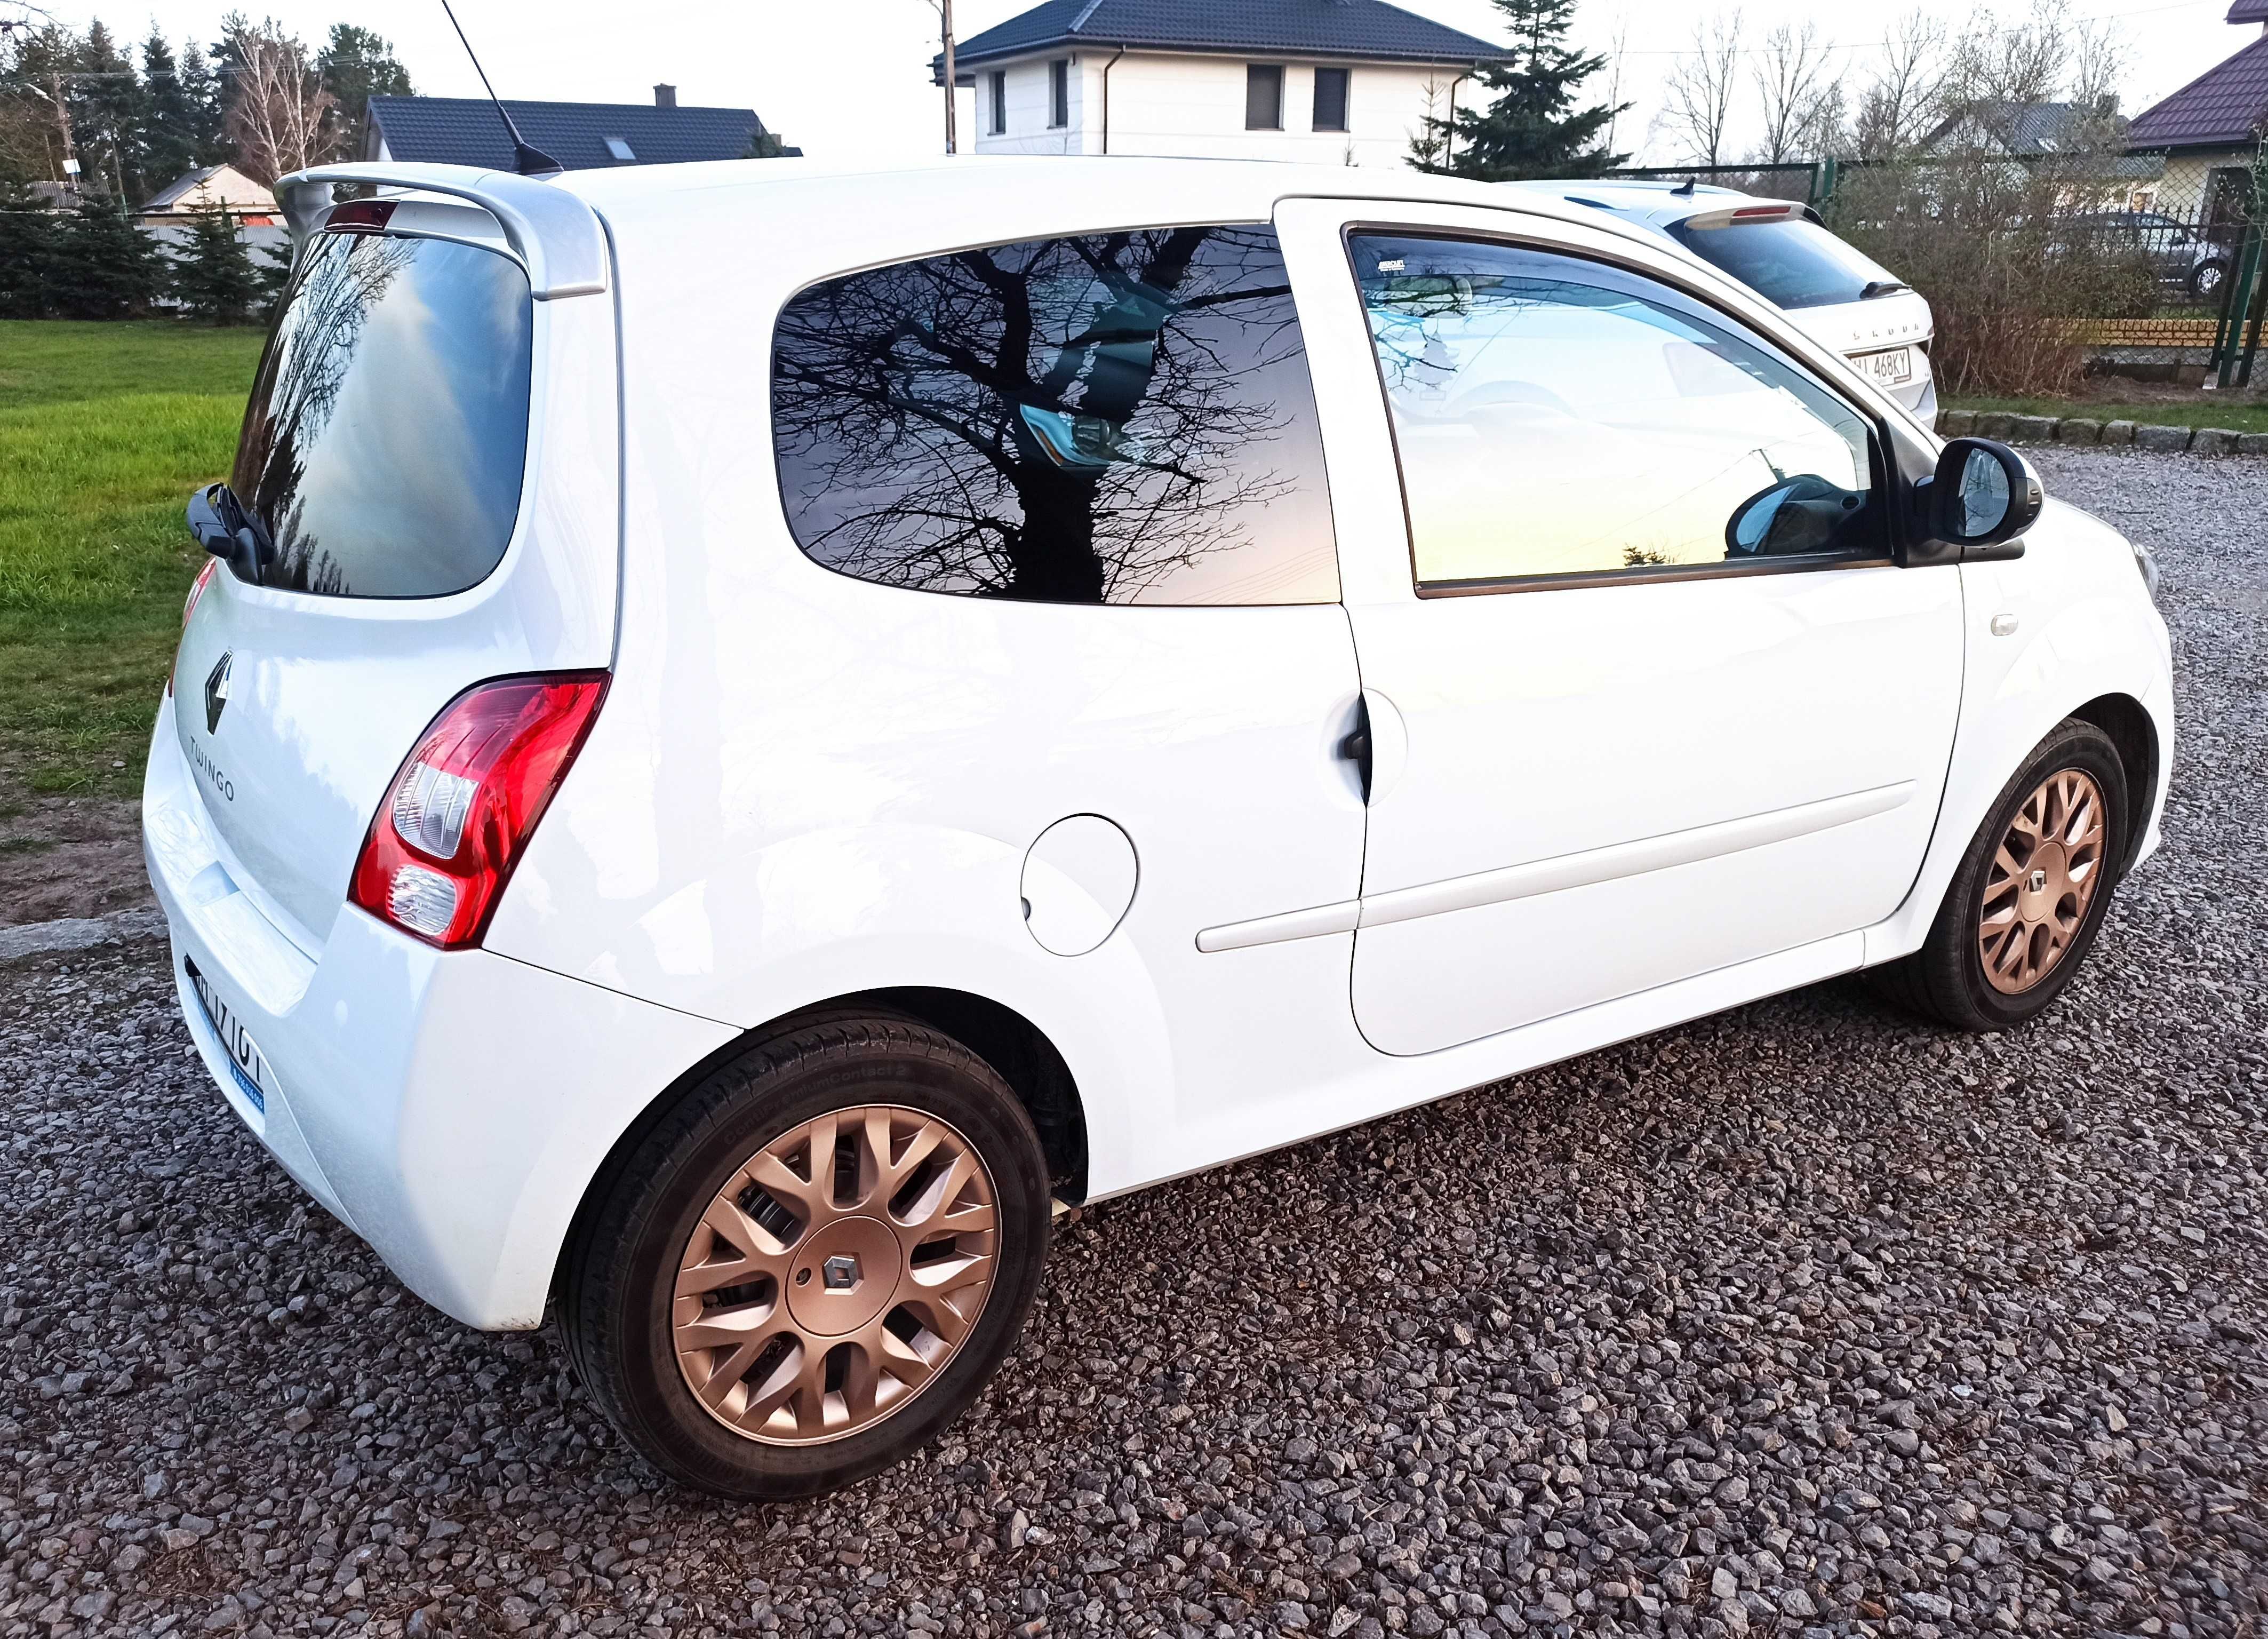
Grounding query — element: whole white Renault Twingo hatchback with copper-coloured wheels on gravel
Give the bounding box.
[145,159,2173,1496]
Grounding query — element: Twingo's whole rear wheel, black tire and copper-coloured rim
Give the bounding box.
[576,1015,1048,1498]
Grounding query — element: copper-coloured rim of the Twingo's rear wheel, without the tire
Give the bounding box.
[669,1103,998,1446]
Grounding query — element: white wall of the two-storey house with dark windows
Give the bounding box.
[975,50,1472,166]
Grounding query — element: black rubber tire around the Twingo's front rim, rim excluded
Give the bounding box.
[1871,718,2130,1033]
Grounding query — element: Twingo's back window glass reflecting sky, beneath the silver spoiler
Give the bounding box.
[229,234,533,597]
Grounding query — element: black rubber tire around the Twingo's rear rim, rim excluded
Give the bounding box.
[560,1013,1050,1500]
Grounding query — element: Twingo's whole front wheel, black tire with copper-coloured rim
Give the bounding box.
[1878,720,2127,1031]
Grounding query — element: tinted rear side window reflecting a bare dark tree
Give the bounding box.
[771,227,1338,604]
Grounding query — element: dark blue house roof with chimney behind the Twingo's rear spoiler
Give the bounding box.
[363,86,803,170]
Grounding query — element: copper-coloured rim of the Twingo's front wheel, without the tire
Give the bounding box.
[1978,767,2103,997]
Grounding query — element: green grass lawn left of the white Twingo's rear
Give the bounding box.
[0,320,261,794]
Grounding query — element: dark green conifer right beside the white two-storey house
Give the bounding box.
[1411,0,1628,181]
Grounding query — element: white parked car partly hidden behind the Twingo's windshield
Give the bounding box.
[1506,179,1937,427]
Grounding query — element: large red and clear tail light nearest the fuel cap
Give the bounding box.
[347,672,605,951]
